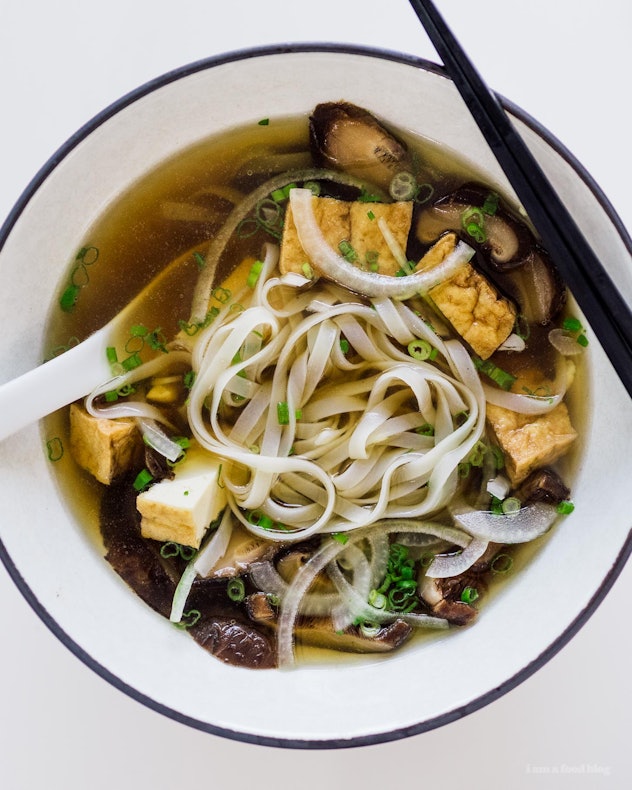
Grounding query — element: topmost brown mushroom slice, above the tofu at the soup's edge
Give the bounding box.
[309,102,411,190]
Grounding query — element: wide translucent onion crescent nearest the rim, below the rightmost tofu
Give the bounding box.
[452,502,558,543]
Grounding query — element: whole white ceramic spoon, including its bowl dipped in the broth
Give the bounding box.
[0,253,197,441]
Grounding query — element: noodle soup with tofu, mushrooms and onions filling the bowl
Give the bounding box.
[47,103,584,667]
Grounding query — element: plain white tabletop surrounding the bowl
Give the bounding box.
[0,0,632,790]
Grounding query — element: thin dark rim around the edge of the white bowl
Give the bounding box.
[0,43,632,749]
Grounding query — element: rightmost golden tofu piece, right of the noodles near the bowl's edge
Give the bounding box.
[487,403,577,485]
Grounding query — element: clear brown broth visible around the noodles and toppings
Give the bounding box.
[46,110,586,661]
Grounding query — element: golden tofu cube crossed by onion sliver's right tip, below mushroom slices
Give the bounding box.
[417,234,516,359]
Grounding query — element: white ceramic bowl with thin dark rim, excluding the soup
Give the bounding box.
[0,45,632,748]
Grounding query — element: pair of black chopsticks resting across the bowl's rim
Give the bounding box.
[410,0,632,396]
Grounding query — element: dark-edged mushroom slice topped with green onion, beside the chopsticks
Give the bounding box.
[417,184,535,271]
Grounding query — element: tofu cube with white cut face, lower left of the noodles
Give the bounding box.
[136,445,226,549]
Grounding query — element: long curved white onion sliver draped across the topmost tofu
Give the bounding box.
[290,189,474,299]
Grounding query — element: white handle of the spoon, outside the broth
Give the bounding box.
[0,326,112,441]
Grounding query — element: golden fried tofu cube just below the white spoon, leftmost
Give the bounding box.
[70,403,143,485]
